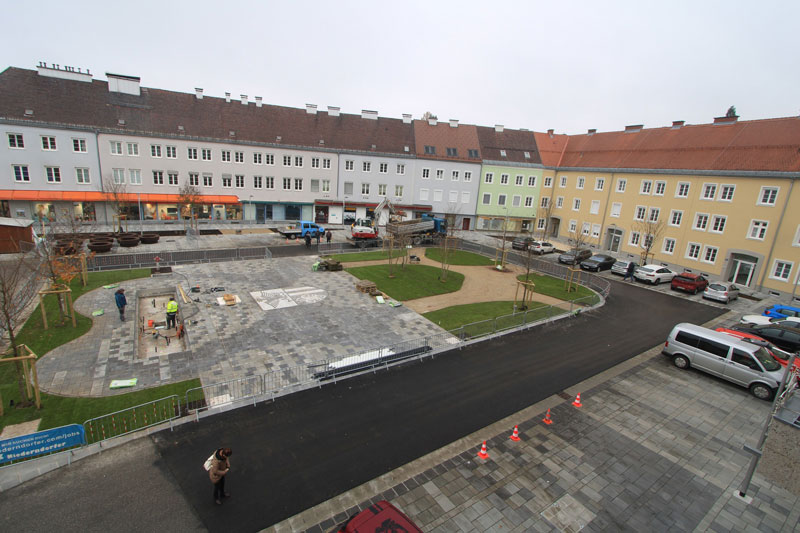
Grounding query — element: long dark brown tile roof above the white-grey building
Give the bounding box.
[0,68,412,156]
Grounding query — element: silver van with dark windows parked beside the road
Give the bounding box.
[661,323,784,400]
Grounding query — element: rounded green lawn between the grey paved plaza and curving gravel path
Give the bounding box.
[347,265,464,301]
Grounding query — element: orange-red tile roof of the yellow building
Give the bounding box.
[552,117,800,172]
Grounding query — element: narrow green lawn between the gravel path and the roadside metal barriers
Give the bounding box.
[422,301,567,337]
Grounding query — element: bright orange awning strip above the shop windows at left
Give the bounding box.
[0,189,241,204]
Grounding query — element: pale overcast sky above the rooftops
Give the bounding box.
[0,0,800,134]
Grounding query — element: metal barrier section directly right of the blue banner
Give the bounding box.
[83,394,181,444]
